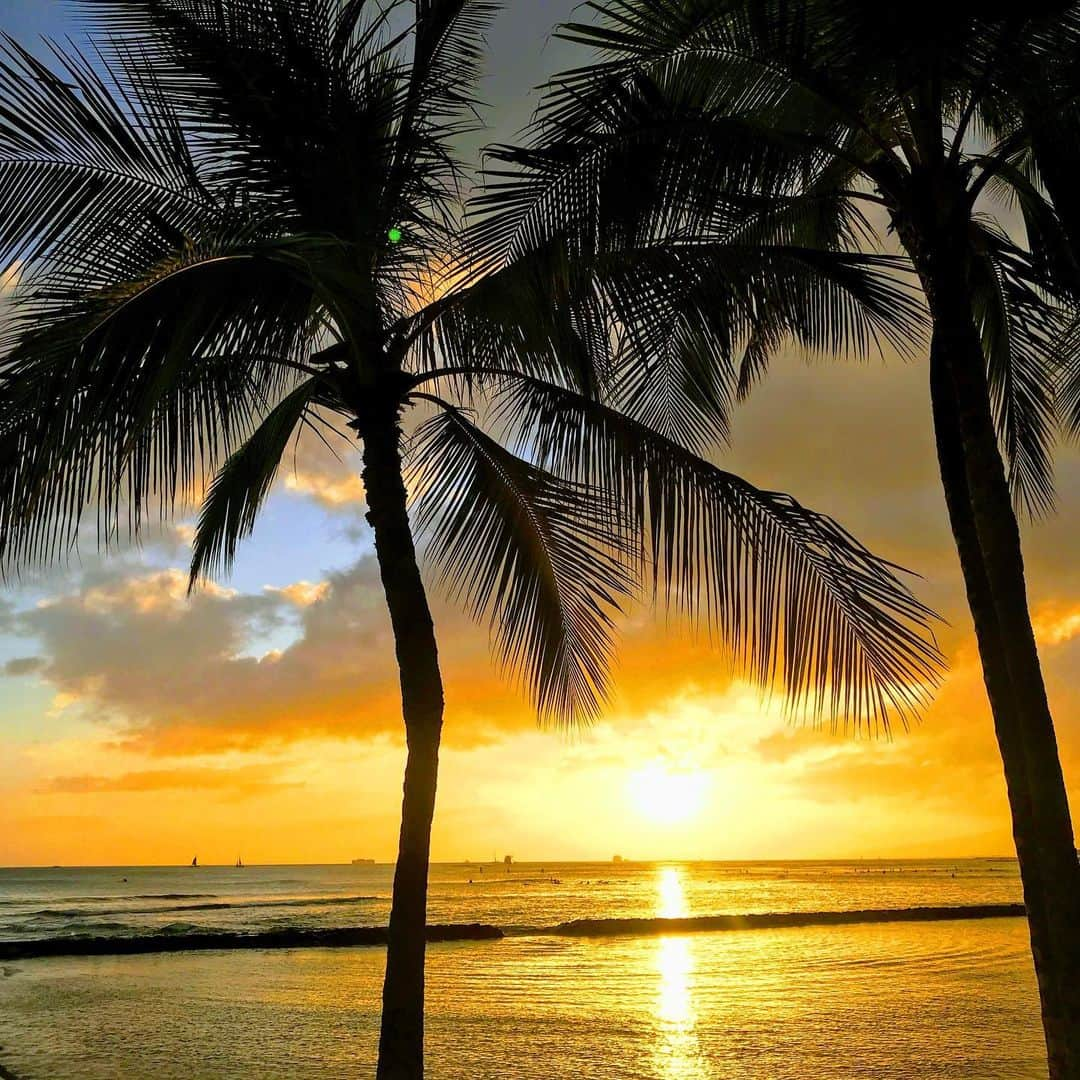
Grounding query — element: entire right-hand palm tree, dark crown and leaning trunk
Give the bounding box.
[486,0,1080,1080]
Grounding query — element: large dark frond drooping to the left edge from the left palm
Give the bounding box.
[0,221,320,574]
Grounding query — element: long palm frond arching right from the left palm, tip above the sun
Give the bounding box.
[486,377,943,728]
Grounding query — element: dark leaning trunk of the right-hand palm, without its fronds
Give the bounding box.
[923,252,1080,1080]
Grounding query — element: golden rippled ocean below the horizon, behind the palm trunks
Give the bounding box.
[0,860,1047,1080]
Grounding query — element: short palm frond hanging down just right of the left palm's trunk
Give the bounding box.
[410,407,633,724]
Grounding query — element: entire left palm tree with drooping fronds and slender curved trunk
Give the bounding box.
[0,0,940,1078]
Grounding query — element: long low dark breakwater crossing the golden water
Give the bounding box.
[0,904,1026,963]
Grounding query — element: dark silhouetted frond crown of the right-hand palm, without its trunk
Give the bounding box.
[491,0,1080,513]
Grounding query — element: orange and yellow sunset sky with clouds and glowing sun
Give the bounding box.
[0,0,1080,865]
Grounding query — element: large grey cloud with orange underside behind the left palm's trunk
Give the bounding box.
[12,556,534,755]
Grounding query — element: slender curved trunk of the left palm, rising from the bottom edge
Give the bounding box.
[363,421,443,1080]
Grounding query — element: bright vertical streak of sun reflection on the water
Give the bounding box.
[653,866,708,1080]
